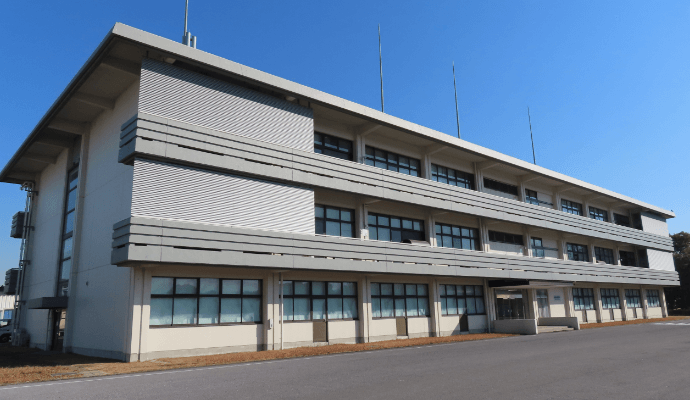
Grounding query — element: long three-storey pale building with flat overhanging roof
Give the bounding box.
[0,24,679,361]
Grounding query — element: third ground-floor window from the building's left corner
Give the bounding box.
[371,283,429,318]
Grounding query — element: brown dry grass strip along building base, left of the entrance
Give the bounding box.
[0,333,506,385]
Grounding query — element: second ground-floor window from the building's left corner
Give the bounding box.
[283,281,357,321]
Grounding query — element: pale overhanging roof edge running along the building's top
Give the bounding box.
[0,22,675,218]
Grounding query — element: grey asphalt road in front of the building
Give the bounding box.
[0,321,690,400]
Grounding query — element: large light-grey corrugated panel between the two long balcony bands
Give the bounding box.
[132,160,314,234]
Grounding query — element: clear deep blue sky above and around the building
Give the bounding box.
[0,0,690,278]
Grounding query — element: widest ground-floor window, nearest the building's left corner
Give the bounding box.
[149,277,262,326]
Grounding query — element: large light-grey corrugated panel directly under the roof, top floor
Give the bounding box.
[139,58,314,151]
